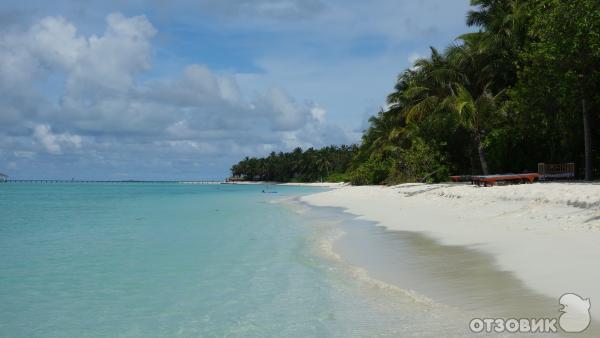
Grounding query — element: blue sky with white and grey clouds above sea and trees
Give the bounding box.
[0,0,470,180]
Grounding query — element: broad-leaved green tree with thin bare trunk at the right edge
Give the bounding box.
[518,0,600,180]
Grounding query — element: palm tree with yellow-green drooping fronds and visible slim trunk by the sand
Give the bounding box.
[384,41,504,174]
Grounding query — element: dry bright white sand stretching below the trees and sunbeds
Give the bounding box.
[302,183,600,319]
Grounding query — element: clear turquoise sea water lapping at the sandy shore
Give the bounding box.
[0,183,468,337]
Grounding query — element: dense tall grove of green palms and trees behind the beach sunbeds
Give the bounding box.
[234,0,600,184]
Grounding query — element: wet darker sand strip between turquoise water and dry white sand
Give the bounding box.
[296,202,600,337]
